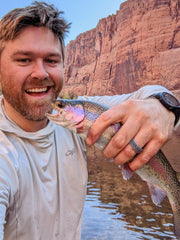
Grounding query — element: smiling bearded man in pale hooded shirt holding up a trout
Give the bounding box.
[0,2,178,240]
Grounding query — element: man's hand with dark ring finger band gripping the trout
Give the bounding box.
[86,98,175,171]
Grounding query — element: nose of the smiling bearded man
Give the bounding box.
[31,60,49,80]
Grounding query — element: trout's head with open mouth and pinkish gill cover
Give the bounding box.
[46,99,85,132]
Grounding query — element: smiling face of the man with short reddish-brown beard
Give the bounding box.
[0,26,63,121]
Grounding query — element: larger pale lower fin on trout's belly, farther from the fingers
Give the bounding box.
[147,183,166,206]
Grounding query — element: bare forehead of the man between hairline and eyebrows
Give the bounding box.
[4,26,62,54]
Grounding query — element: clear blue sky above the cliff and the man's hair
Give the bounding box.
[0,0,125,45]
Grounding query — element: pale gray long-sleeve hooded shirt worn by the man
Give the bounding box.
[0,86,172,240]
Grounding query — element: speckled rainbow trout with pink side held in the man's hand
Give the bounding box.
[47,99,180,239]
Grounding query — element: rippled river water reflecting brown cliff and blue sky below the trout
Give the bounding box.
[82,147,176,240]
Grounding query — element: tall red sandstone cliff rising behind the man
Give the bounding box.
[64,0,180,95]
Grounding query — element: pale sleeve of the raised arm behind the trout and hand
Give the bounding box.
[78,85,172,107]
